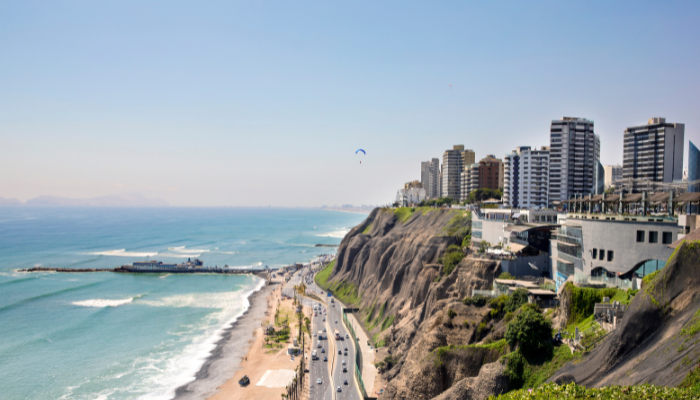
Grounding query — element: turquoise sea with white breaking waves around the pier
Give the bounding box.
[0,207,365,399]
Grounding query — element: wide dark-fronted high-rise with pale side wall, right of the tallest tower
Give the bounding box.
[622,118,685,190]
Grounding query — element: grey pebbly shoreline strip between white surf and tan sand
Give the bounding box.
[172,283,277,400]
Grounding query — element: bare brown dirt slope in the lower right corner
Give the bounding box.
[550,242,700,387]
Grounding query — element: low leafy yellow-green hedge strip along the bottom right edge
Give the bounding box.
[489,383,700,400]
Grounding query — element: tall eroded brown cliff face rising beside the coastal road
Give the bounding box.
[329,209,504,400]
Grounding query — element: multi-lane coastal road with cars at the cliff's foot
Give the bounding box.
[283,268,362,400]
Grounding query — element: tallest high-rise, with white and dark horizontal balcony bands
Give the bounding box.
[549,117,600,203]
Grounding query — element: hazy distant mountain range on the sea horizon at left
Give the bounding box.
[9,193,169,207]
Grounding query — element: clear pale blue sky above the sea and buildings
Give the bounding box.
[0,0,700,207]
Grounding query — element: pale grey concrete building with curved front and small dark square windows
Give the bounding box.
[550,213,679,289]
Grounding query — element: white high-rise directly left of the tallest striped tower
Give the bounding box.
[503,146,550,208]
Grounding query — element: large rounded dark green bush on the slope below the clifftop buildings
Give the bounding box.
[506,309,552,355]
